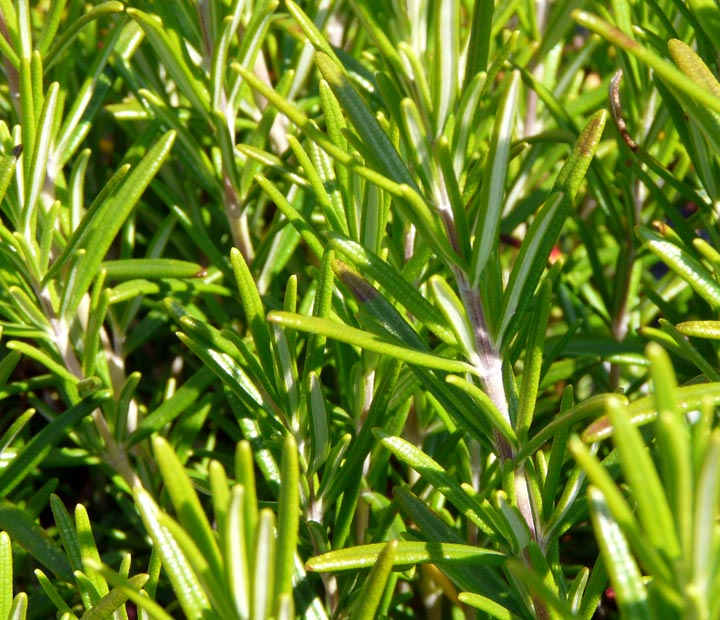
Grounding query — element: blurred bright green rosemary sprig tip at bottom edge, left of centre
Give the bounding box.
[93,435,316,619]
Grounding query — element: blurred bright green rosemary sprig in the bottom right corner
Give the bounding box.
[570,345,720,618]
